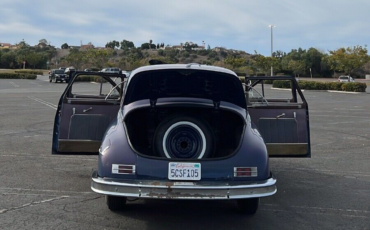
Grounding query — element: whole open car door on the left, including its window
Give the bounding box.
[52,72,125,154]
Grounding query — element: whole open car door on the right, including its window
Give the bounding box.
[245,76,311,157]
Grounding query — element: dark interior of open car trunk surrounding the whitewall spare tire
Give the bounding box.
[124,105,244,160]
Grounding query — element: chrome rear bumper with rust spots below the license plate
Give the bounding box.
[91,172,277,200]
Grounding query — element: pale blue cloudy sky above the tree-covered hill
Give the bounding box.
[0,0,370,55]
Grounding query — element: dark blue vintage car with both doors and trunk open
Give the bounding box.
[52,64,311,214]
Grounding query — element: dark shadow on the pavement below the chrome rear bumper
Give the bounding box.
[117,199,262,229]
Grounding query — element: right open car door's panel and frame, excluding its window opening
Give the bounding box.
[248,77,311,157]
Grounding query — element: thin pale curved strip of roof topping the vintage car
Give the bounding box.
[128,63,238,83]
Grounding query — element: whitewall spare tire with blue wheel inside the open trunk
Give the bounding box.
[153,114,215,159]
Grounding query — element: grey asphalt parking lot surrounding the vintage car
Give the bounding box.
[0,76,370,230]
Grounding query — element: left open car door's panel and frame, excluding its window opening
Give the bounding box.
[52,72,124,154]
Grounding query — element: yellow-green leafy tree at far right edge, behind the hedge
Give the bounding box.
[328,46,370,74]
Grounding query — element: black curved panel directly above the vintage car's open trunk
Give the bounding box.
[124,70,246,108]
